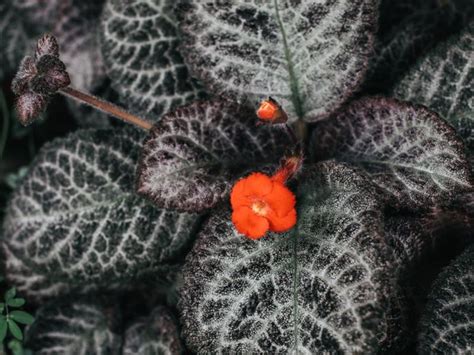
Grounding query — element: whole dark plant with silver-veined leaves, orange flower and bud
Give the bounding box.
[0,0,474,354]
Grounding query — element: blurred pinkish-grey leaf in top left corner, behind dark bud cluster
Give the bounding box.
[14,0,105,90]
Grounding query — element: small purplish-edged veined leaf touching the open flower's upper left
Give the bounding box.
[138,101,292,211]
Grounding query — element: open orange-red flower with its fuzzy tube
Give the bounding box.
[230,158,300,239]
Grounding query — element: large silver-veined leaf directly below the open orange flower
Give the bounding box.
[179,162,393,354]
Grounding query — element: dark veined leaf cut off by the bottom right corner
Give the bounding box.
[418,247,474,354]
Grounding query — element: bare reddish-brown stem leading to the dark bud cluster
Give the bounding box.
[59,86,153,130]
